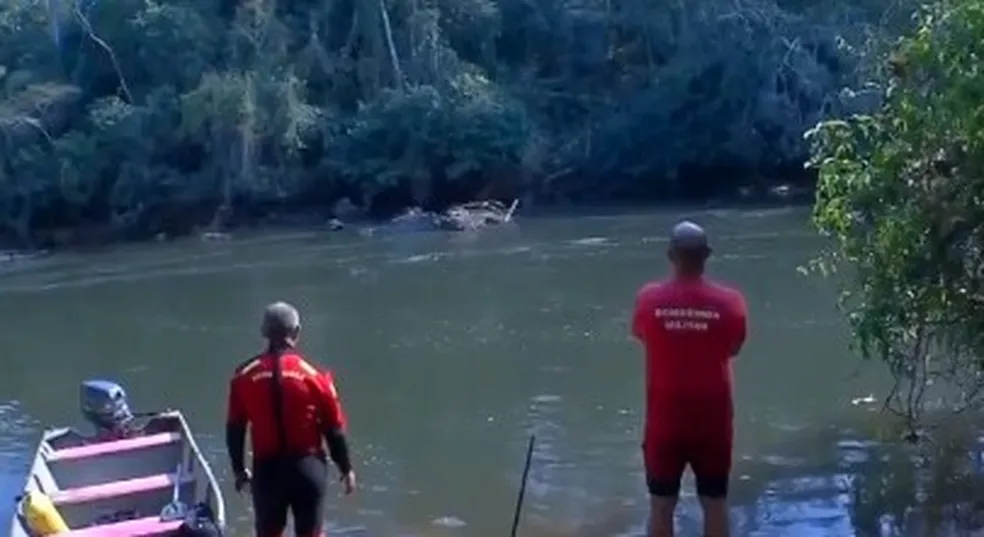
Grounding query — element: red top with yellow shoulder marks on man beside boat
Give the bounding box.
[227,352,345,460]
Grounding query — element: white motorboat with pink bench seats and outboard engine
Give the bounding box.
[9,380,225,537]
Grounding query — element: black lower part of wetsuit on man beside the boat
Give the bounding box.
[252,456,328,537]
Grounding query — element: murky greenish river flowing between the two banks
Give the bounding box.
[0,209,968,537]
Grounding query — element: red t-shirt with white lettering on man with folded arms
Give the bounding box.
[632,279,747,437]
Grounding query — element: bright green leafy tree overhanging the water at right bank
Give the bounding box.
[810,0,984,426]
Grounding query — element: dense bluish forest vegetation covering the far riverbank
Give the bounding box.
[0,0,906,240]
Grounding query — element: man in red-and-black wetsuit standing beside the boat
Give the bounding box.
[226,302,355,537]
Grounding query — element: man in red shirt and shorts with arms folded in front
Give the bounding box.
[632,221,747,537]
